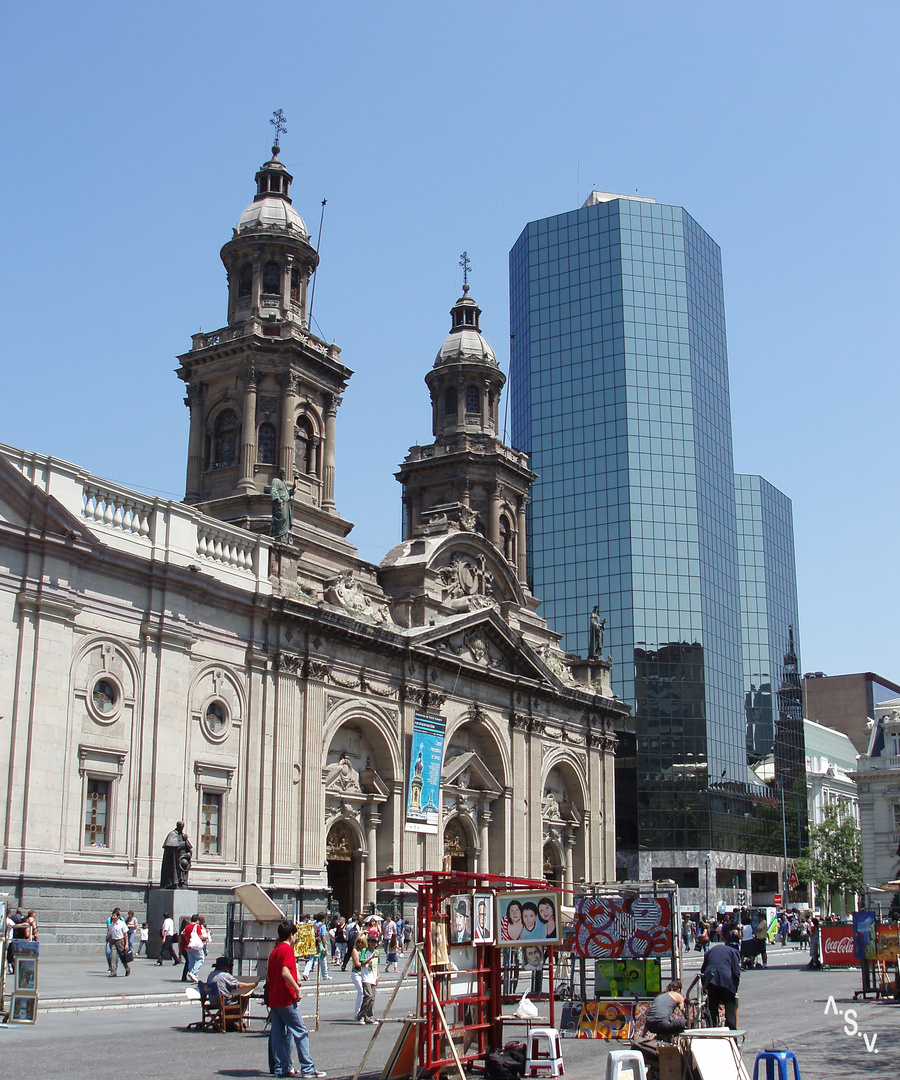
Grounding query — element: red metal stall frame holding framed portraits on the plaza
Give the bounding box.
[368,870,564,1076]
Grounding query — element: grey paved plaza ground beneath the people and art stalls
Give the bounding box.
[0,948,900,1080]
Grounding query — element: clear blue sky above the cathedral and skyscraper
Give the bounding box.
[0,0,900,679]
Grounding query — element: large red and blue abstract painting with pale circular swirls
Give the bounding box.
[572,896,672,959]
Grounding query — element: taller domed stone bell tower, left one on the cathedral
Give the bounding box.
[177,144,352,548]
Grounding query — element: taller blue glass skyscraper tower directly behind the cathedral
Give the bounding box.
[510,197,750,850]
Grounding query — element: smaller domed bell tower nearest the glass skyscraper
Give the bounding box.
[395,284,535,586]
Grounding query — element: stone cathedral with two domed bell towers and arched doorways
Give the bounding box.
[0,146,628,951]
